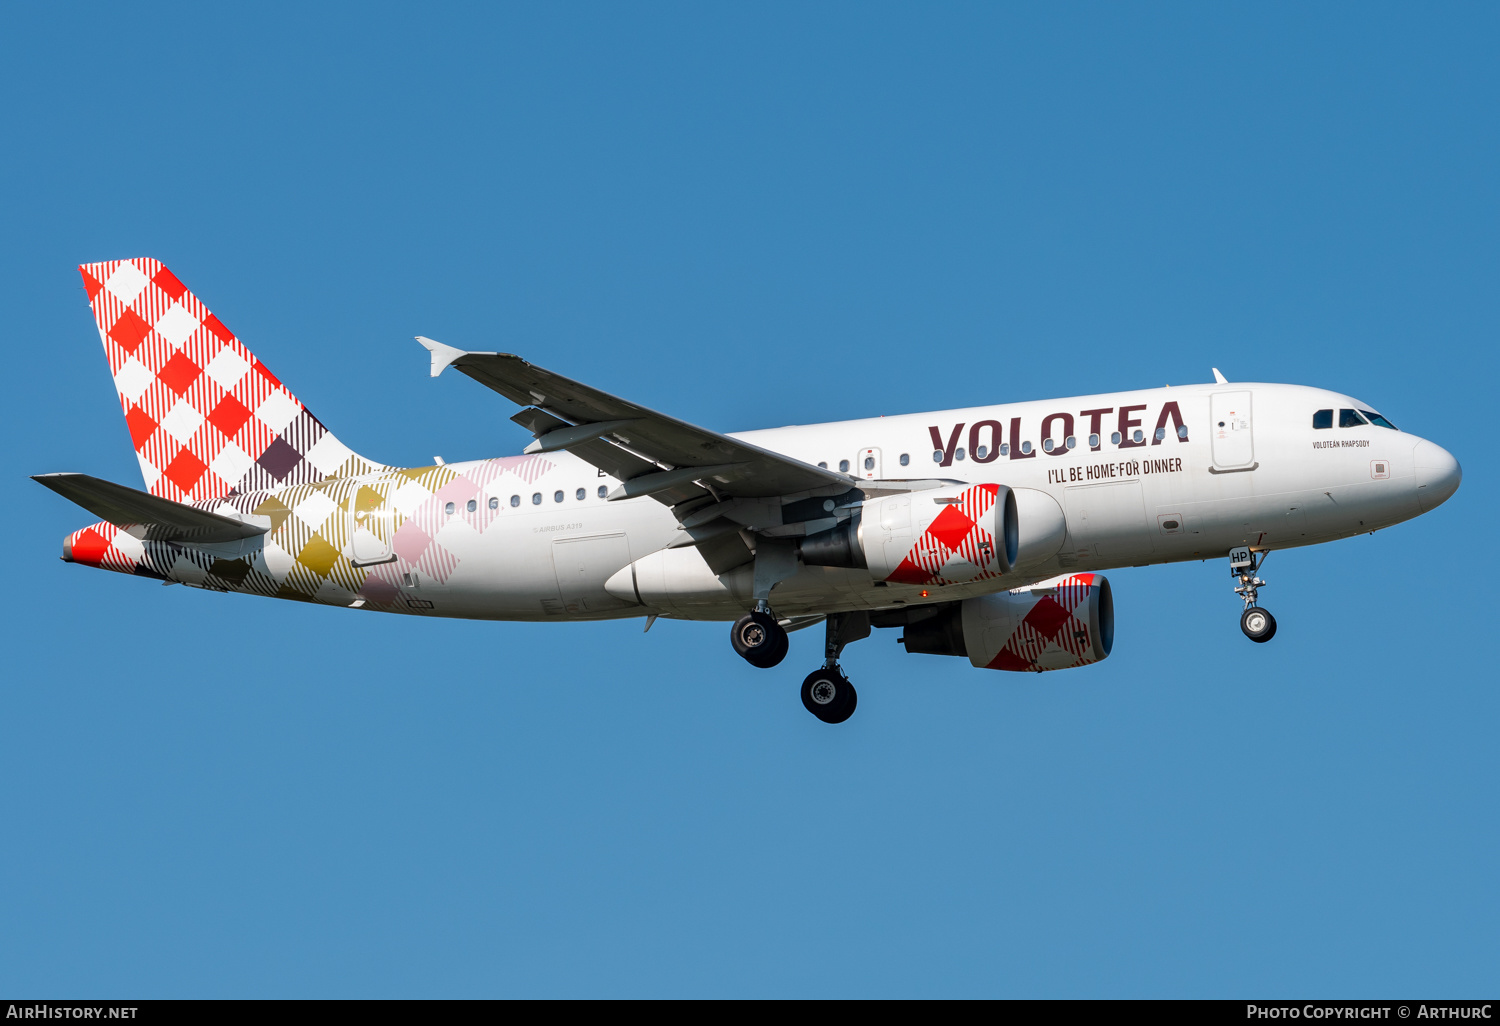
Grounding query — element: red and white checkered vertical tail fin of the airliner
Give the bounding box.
[78,258,378,503]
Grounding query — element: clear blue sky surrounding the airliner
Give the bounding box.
[0,3,1500,996]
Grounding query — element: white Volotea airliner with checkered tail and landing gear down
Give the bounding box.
[35,258,1461,723]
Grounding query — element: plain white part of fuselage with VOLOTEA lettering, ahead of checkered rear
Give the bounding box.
[410,384,1458,620]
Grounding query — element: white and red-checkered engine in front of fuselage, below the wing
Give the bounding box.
[801,485,1068,585]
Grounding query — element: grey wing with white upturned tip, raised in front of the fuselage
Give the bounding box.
[417,336,855,504]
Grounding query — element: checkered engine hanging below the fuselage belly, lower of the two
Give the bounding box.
[902,573,1115,672]
